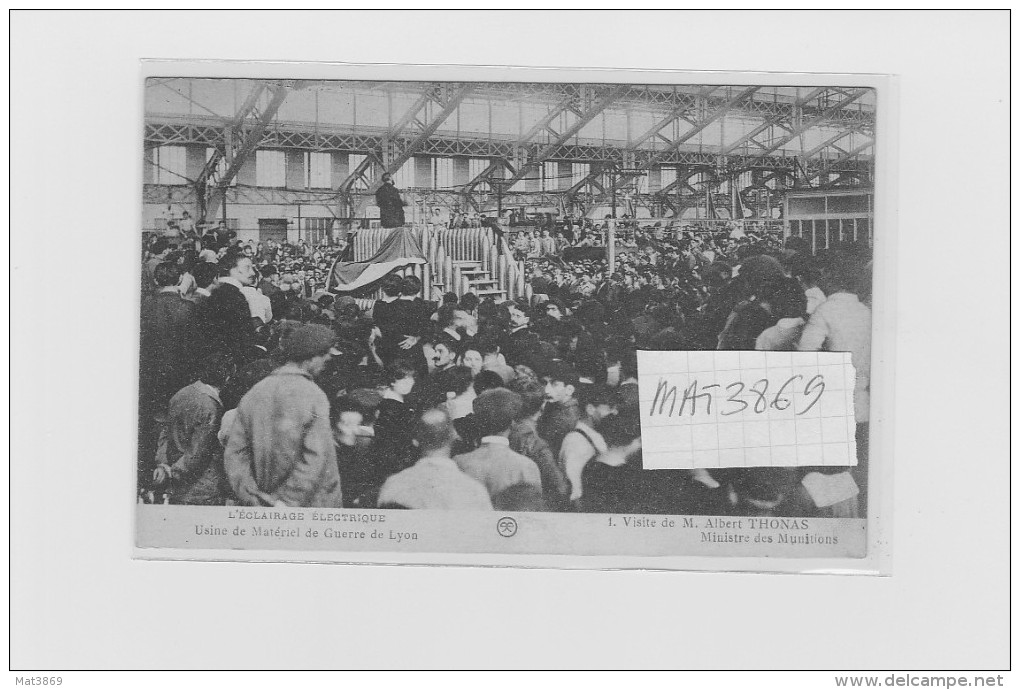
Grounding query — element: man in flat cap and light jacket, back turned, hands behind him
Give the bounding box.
[223,324,343,508]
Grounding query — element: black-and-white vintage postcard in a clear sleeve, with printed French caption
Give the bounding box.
[135,64,895,573]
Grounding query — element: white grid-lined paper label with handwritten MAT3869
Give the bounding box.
[638,350,857,470]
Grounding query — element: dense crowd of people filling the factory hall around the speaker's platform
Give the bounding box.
[139,214,871,516]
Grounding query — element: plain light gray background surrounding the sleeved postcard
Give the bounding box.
[11,12,1010,669]
